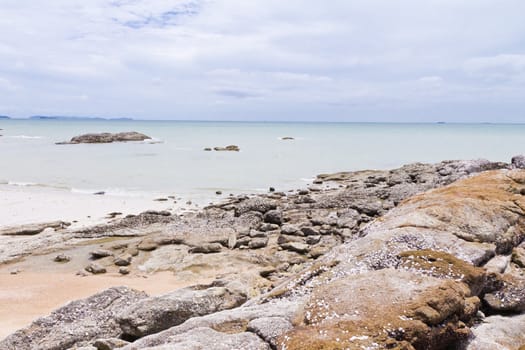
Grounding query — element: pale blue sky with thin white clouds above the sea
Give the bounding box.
[0,0,525,122]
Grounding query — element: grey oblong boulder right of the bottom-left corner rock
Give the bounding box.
[117,286,246,337]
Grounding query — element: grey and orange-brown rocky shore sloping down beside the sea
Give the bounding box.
[0,156,525,350]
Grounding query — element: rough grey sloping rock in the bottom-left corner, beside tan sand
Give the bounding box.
[0,287,146,350]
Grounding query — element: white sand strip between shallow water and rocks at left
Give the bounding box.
[0,185,201,228]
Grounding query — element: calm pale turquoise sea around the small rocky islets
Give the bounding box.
[0,120,525,202]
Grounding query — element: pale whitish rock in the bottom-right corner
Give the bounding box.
[464,315,525,350]
